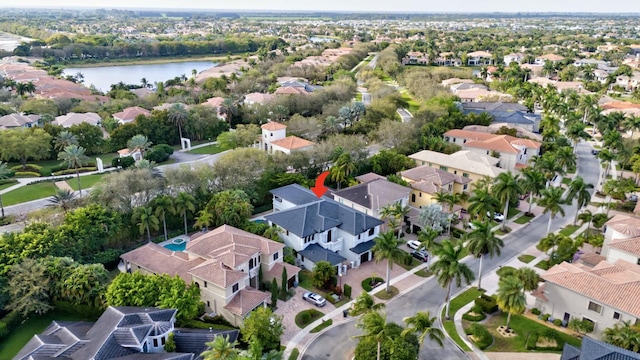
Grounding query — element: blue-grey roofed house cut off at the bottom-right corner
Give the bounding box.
[560,336,640,360]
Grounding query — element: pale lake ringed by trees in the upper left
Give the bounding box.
[64,61,217,92]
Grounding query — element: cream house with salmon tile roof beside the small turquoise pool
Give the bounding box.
[120,225,300,326]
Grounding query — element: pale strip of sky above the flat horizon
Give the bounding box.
[5,0,640,14]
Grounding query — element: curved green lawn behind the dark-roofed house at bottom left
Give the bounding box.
[0,311,96,359]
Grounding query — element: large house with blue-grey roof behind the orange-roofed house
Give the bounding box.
[461,102,540,132]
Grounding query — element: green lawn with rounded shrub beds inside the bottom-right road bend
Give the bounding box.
[478,314,580,352]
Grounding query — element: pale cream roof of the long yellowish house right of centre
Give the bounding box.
[409,150,506,177]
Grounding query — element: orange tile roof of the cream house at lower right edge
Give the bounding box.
[542,260,640,317]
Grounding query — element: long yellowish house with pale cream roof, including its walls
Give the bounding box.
[409,150,506,184]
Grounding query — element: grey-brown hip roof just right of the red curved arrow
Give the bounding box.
[333,178,411,210]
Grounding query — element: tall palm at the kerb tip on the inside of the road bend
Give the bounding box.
[431,240,474,320]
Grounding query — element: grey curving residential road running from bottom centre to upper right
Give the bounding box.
[302,142,600,360]
